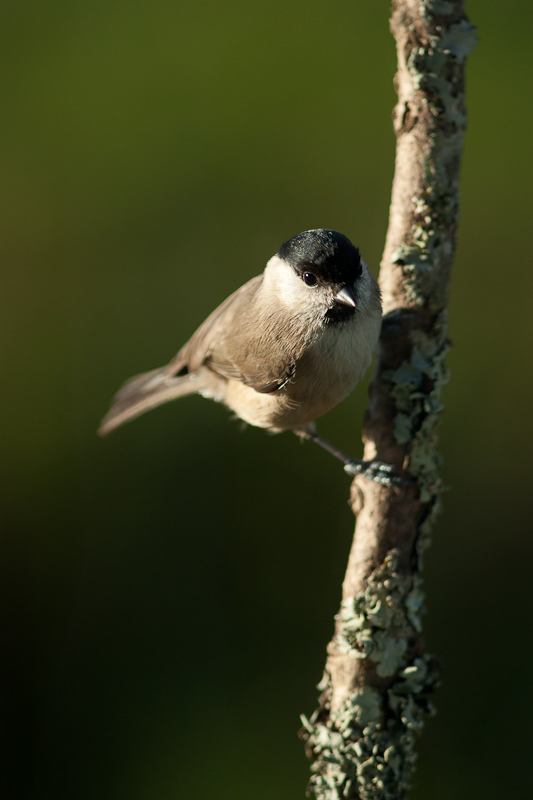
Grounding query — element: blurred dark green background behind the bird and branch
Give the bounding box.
[0,0,533,800]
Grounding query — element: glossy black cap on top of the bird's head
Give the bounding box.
[277,228,362,285]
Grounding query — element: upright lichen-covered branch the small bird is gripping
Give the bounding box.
[303,0,475,800]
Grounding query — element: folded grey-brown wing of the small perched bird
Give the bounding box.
[167,275,294,393]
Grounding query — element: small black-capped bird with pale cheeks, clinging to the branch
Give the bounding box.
[99,228,395,484]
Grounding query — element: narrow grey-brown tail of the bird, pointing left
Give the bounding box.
[98,367,203,436]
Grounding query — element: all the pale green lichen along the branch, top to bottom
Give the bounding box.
[302,0,476,800]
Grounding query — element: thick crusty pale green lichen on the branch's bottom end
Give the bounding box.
[302,550,436,800]
